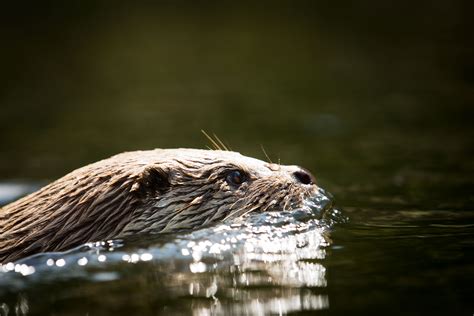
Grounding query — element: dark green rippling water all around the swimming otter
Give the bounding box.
[0,0,474,316]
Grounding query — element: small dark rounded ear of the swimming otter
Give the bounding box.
[130,166,170,197]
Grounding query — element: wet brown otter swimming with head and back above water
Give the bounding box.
[0,148,318,263]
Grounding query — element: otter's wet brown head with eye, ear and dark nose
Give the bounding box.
[121,149,317,235]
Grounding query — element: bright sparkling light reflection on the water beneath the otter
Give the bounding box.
[0,190,343,315]
